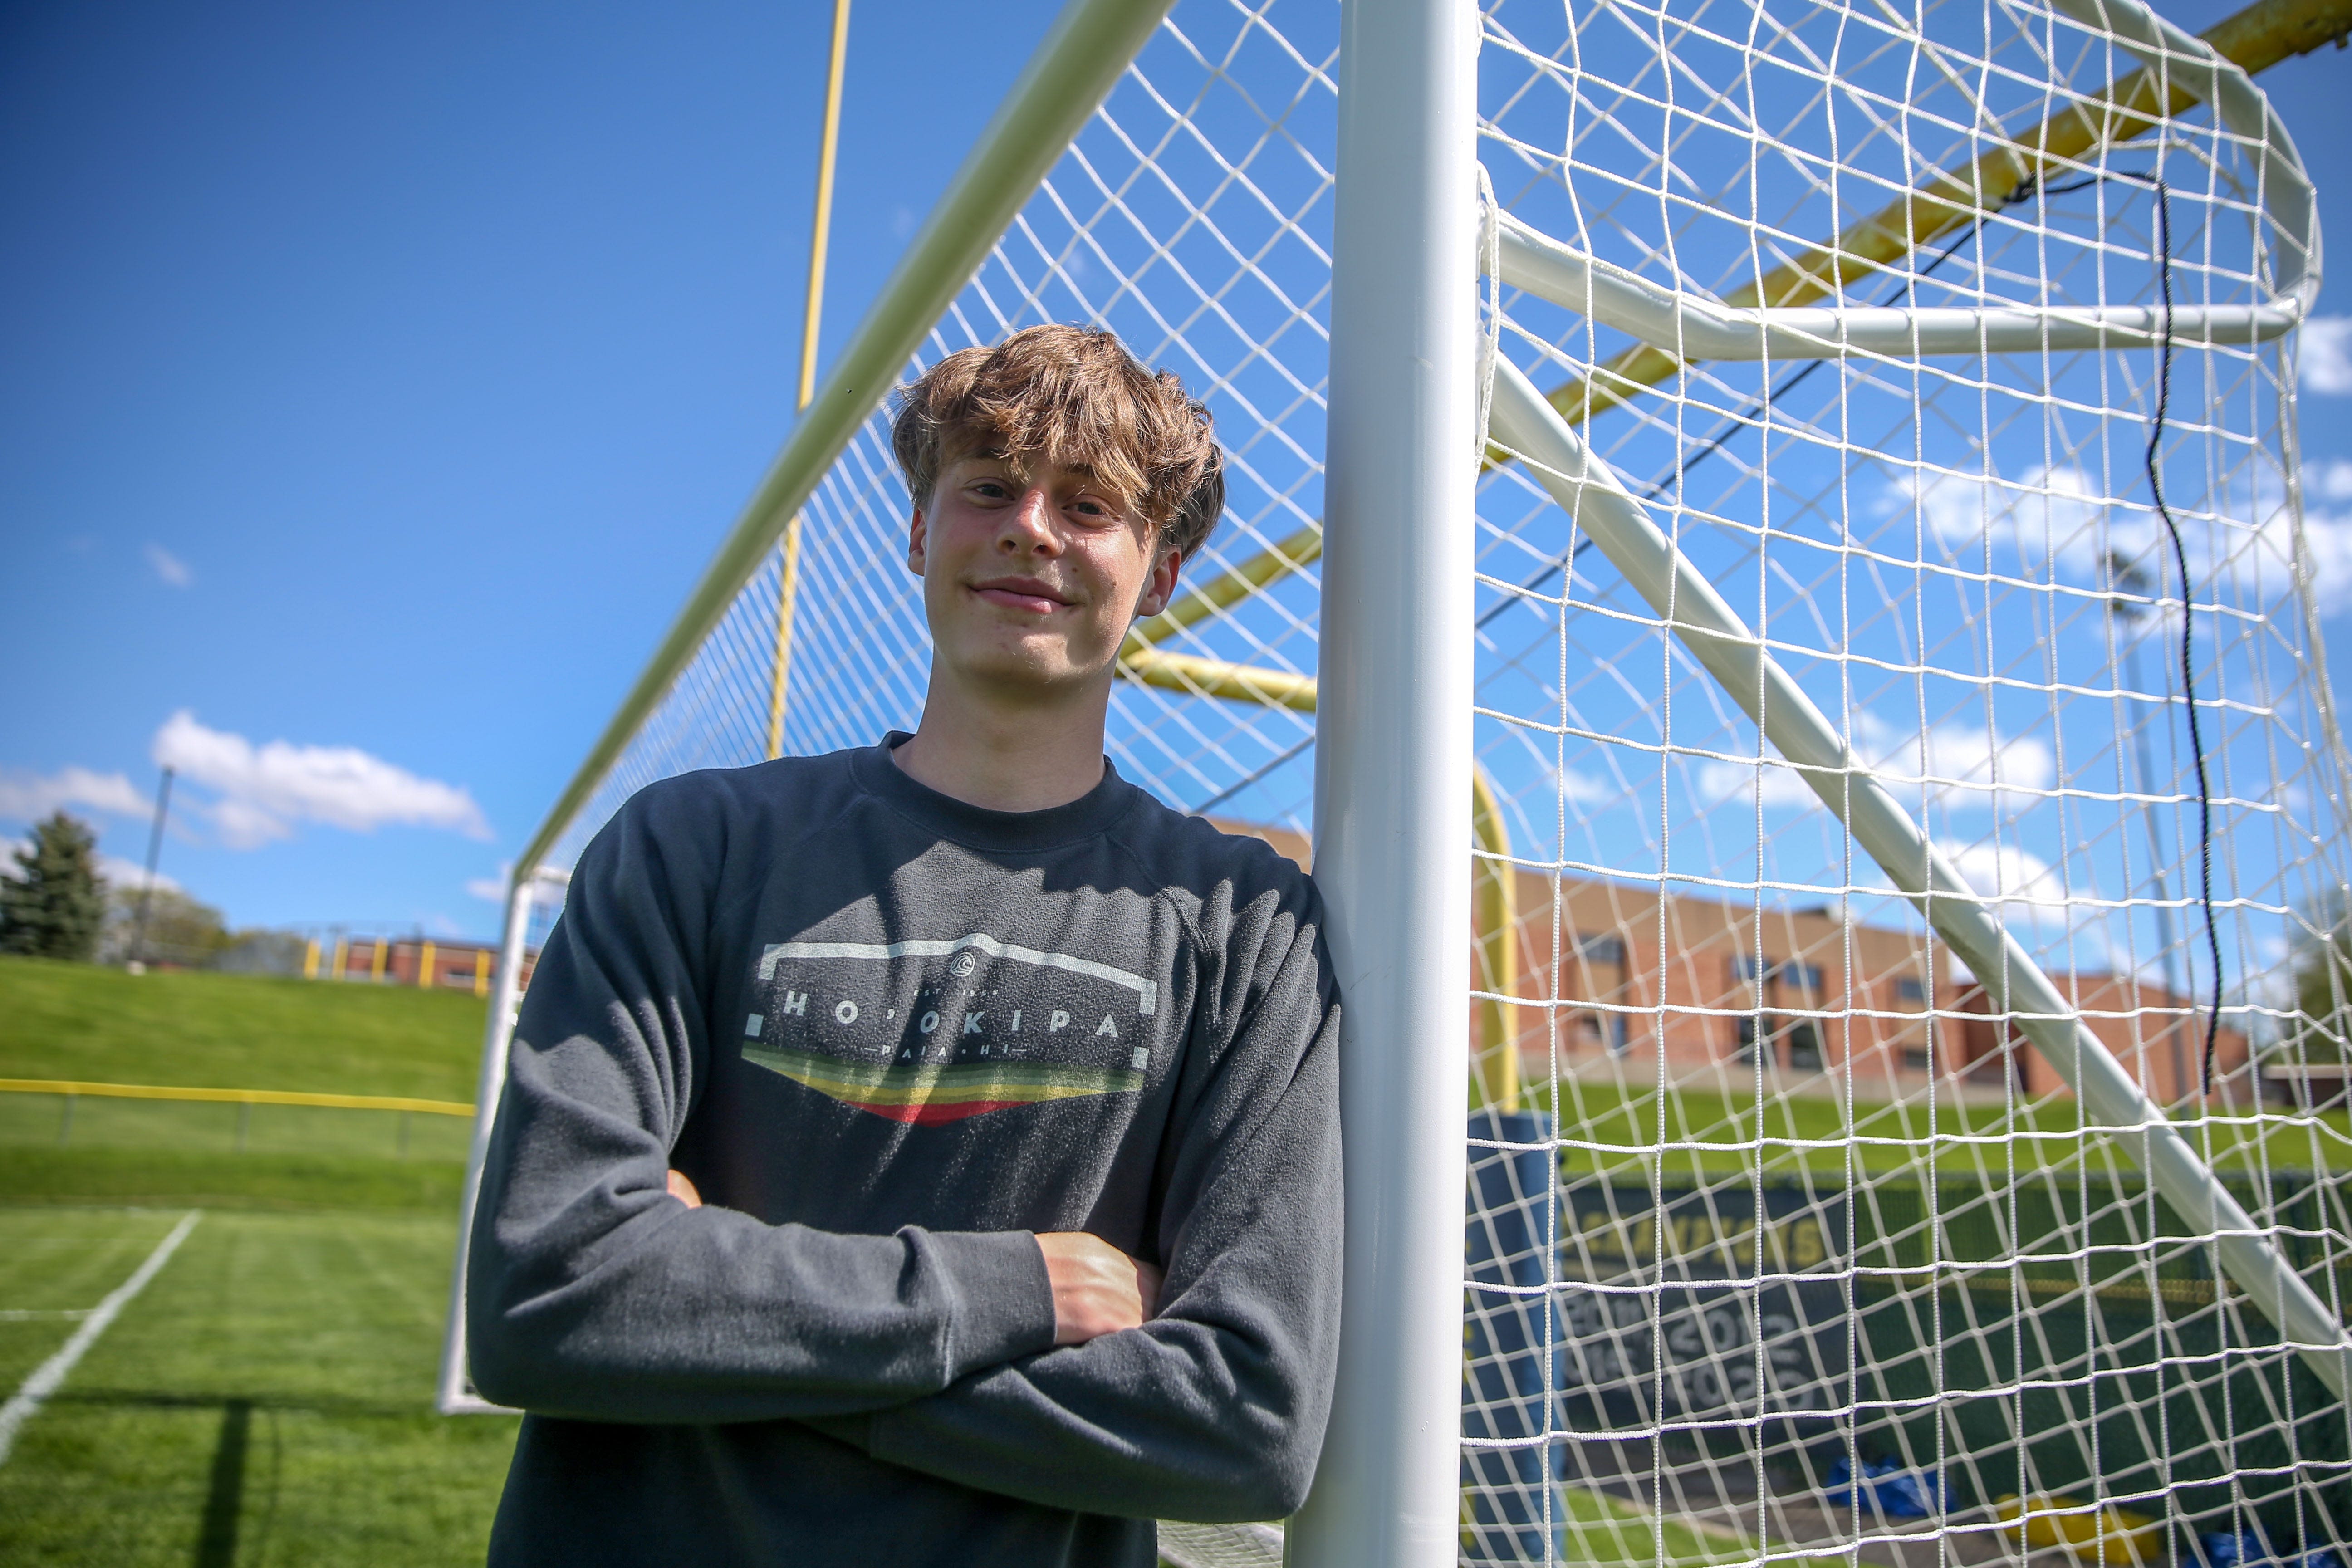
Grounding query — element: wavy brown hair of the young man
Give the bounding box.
[892,324,1225,555]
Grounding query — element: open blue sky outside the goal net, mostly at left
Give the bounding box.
[0,0,2352,936]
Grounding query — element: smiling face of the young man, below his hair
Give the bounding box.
[906,454,1178,696]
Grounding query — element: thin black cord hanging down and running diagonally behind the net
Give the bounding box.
[1477,169,2223,1093]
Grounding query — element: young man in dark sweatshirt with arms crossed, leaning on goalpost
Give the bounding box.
[468,327,1341,1568]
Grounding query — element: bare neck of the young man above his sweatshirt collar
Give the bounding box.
[892,672,1110,811]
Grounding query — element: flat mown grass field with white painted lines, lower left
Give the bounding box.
[0,1208,515,1568]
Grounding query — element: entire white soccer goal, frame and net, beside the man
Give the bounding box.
[445,0,2352,1566]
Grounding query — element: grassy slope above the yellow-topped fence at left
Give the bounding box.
[0,957,487,1100]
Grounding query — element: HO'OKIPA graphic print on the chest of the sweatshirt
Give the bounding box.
[743,931,1164,1124]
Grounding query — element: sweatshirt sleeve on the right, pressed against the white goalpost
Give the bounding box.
[814,879,1341,1521]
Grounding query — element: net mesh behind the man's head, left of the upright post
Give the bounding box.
[539,5,1338,863]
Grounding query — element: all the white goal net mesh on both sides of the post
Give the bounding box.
[519,0,2352,1568]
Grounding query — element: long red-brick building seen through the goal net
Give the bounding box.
[1220,823,2253,1105]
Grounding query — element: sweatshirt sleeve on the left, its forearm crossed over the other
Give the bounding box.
[466,778,1054,1422]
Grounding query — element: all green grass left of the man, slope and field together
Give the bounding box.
[0,959,515,1568]
